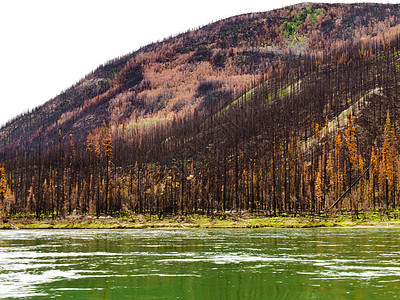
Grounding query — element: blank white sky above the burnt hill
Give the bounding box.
[0,0,397,125]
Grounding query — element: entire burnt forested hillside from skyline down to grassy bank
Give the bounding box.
[0,4,400,218]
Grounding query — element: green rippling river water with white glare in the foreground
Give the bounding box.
[0,228,400,299]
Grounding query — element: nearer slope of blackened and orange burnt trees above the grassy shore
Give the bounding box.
[0,30,400,217]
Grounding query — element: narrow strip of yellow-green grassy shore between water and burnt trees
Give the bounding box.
[0,210,400,229]
